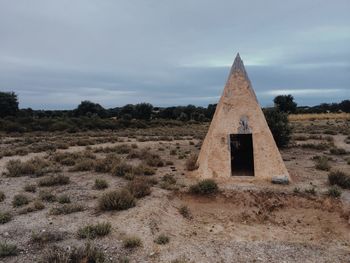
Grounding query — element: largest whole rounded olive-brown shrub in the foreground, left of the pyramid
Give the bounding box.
[98,189,136,211]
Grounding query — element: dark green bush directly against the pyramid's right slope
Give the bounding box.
[264,108,292,147]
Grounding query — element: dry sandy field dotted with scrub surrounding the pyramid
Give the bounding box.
[0,118,350,263]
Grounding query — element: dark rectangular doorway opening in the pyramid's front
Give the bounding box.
[230,134,254,176]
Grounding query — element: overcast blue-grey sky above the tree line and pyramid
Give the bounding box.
[0,0,350,109]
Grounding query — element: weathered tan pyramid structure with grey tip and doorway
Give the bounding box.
[196,54,290,180]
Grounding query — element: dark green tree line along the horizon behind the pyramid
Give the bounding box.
[0,92,350,121]
